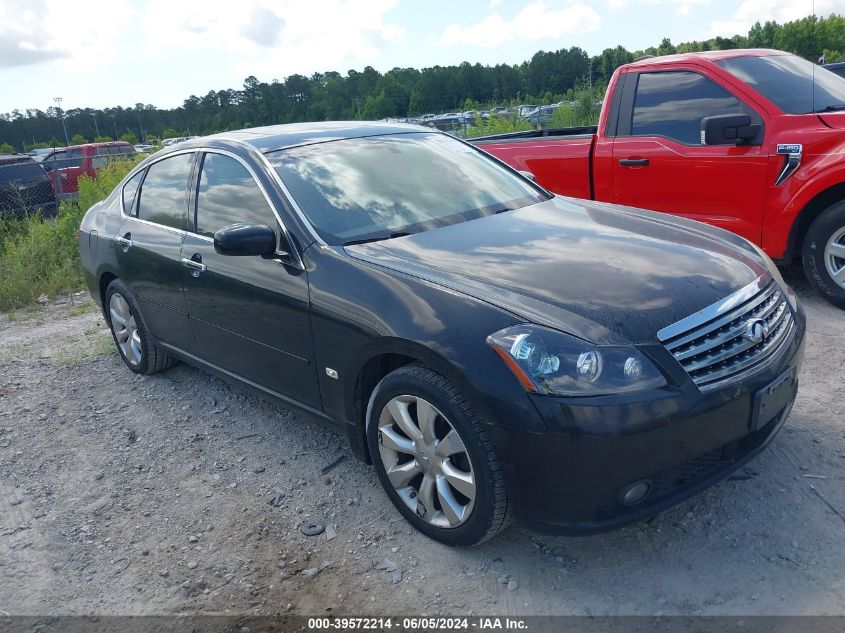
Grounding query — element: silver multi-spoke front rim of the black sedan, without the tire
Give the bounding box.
[378,395,476,529]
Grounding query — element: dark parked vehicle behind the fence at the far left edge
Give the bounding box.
[0,154,56,217]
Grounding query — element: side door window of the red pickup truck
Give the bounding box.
[631,71,760,145]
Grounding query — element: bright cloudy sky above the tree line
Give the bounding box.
[0,0,845,112]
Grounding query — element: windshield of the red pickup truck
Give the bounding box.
[716,55,845,114]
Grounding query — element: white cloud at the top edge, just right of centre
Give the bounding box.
[435,2,602,48]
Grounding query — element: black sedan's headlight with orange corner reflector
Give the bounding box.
[487,325,666,396]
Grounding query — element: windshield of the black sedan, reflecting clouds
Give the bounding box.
[268,132,547,244]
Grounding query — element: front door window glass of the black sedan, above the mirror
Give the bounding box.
[196,153,277,237]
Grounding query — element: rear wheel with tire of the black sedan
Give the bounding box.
[104,279,176,375]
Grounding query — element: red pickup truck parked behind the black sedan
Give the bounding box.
[472,49,845,308]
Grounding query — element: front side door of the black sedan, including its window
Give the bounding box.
[182,152,321,409]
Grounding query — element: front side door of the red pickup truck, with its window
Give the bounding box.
[612,70,769,244]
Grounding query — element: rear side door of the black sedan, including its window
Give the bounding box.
[114,152,195,351]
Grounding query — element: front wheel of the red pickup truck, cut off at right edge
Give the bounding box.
[801,201,845,309]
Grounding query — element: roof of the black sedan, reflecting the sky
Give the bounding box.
[197,121,436,154]
